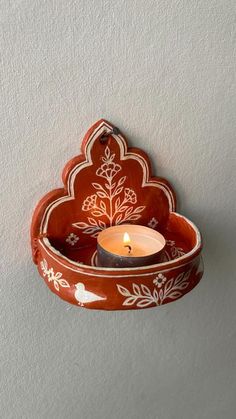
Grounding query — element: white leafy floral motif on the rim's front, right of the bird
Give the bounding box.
[117,270,191,308]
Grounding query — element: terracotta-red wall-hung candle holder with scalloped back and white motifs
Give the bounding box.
[31,120,203,310]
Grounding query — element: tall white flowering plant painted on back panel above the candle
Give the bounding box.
[72,146,145,237]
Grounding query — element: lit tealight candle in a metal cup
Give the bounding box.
[97,224,166,268]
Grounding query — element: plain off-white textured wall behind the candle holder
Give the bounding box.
[0,0,236,419]
